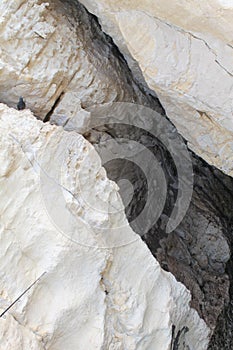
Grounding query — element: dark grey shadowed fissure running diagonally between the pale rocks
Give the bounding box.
[54,0,233,350]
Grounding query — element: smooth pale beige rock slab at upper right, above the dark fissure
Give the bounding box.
[81,0,233,176]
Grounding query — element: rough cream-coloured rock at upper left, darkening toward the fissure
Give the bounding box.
[0,0,157,121]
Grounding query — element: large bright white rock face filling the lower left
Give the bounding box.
[0,104,209,350]
